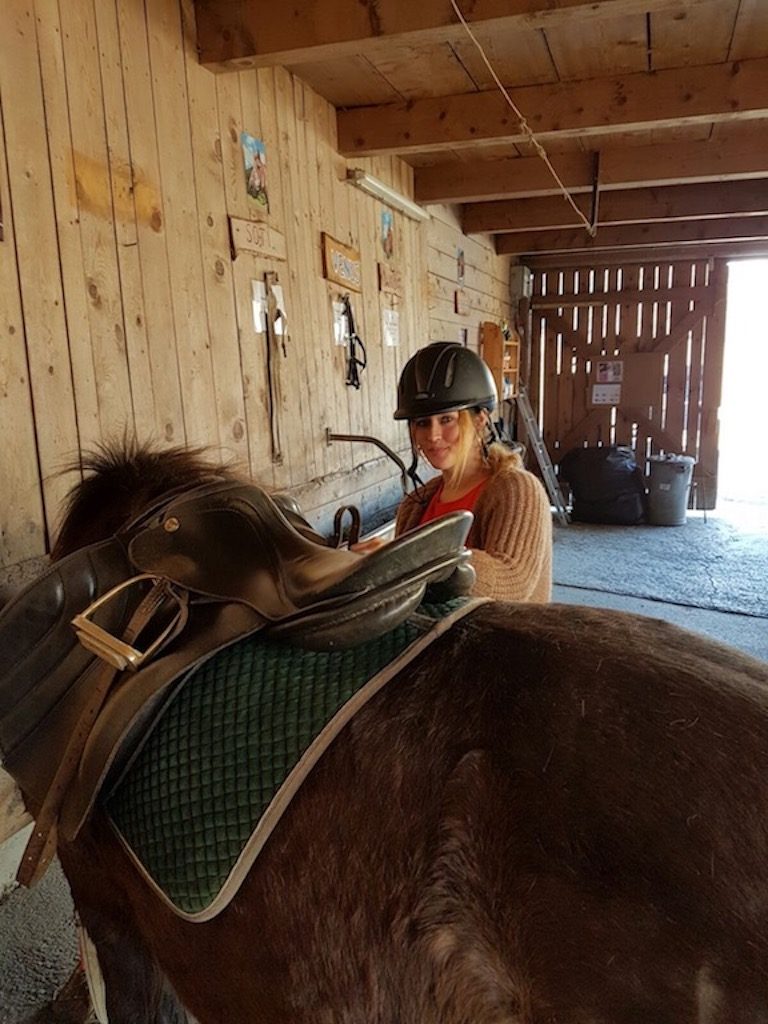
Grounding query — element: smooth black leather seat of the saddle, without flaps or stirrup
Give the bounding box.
[126,482,474,649]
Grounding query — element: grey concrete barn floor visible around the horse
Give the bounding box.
[0,506,768,1024]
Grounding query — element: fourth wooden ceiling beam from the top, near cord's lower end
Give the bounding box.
[462,178,768,234]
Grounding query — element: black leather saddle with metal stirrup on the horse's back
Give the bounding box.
[0,481,474,877]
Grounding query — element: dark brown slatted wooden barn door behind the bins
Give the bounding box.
[530,260,727,508]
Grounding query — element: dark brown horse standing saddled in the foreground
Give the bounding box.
[4,447,768,1024]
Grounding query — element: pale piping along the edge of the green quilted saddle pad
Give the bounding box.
[112,597,492,922]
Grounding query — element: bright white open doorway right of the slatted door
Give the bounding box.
[718,259,768,513]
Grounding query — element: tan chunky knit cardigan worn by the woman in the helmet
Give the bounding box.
[395,445,552,603]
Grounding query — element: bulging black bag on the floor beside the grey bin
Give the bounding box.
[559,444,646,526]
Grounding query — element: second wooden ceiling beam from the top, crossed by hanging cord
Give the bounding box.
[337,57,768,157]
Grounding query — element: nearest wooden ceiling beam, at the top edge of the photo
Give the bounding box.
[196,0,708,71]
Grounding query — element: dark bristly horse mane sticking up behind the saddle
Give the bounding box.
[51,440,239,561]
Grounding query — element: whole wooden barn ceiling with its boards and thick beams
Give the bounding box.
[196,0,768,260]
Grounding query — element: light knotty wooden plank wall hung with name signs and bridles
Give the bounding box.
[0,0,518,567]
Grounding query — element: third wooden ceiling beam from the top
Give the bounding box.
[414,135,768,204]
